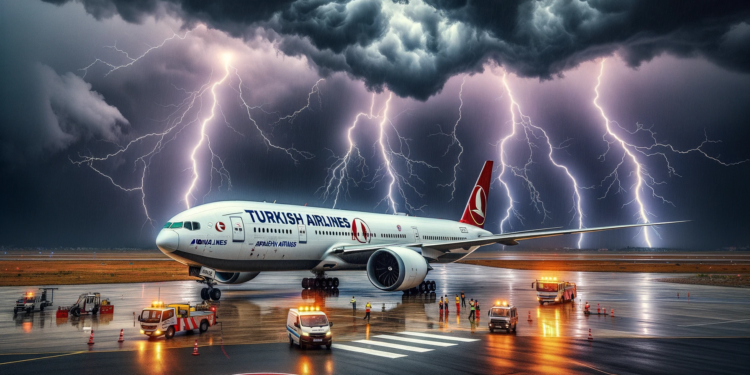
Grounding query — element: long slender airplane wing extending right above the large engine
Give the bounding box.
[331,220,689,258]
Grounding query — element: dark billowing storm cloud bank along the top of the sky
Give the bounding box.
[44,0,750,99]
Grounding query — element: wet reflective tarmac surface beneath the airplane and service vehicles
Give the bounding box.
[0,264,750,374]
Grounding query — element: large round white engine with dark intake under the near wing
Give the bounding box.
[367,247,427,292]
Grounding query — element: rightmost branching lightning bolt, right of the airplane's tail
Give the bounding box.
[593,59,748,247]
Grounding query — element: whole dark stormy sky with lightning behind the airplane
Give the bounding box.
[0,0,750,249]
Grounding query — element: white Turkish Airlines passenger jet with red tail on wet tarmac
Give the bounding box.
[156,160,683,300]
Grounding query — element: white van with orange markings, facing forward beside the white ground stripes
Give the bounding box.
[286,306,333,349]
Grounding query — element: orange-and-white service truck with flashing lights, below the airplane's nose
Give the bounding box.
[138,301,216,339]
